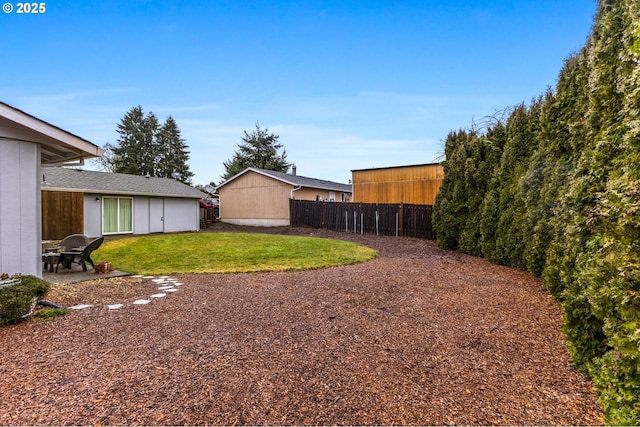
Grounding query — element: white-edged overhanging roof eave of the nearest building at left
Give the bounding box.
[0,102,104,164]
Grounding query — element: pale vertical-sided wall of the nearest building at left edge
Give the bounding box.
[0,140,42,277]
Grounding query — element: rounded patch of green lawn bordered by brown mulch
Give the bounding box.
[91,233,377,275]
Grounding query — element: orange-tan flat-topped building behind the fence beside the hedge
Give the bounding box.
[351,163,444,205]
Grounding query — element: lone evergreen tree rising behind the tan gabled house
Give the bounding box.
[221,123,291,181]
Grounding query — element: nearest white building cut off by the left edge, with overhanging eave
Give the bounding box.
[0,102,103,277]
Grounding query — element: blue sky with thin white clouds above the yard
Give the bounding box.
[0,0,596,184]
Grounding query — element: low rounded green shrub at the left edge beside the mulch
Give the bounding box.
[0,276,49,326]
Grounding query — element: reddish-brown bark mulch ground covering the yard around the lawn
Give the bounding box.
[0,225,602,425]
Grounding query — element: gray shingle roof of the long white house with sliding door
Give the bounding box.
[42,167,207,199]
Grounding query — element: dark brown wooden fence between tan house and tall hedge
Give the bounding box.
[289,199,436,239]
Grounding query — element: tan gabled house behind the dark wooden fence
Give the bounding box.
[216,168,351,226]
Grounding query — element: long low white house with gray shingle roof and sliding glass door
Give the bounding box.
[42,167,206,239]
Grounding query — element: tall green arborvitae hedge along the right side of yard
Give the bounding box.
[434,0,640,425]
